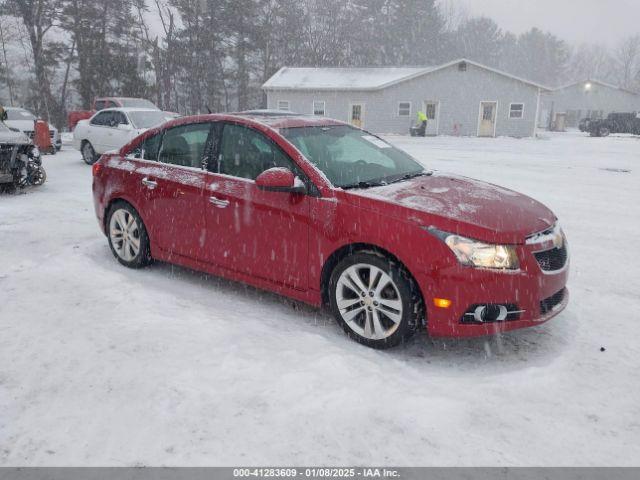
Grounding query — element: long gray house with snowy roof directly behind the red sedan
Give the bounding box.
[262,59,547,137]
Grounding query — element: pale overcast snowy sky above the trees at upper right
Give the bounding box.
[459,0,640,46]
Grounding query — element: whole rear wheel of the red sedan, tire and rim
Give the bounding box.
[107,202,151,268]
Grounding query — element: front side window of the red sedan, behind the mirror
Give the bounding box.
[215,124,299,180]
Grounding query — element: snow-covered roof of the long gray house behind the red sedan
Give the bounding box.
[262,58,550,90]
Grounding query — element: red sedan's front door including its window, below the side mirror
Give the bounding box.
[205,124,309,290]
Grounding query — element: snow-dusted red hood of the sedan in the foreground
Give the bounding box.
[344,173,557,244]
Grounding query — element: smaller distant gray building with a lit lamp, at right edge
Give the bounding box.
[539,80,640,127]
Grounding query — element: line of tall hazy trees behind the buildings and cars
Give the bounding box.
[0,0,640,127]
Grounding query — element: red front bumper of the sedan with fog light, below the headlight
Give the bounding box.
[417,240,569,337]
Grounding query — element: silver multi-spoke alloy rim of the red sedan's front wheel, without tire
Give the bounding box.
[335,263,402,340]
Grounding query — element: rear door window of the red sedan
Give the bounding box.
[158,123,211,168]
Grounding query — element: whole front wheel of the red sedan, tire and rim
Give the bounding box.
[329,252,423,349]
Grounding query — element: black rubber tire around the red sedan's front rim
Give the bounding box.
[329,251,424,349]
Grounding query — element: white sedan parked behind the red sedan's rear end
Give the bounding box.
[73,108,175,165]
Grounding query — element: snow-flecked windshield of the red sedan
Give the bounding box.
[280,125,427,188]
